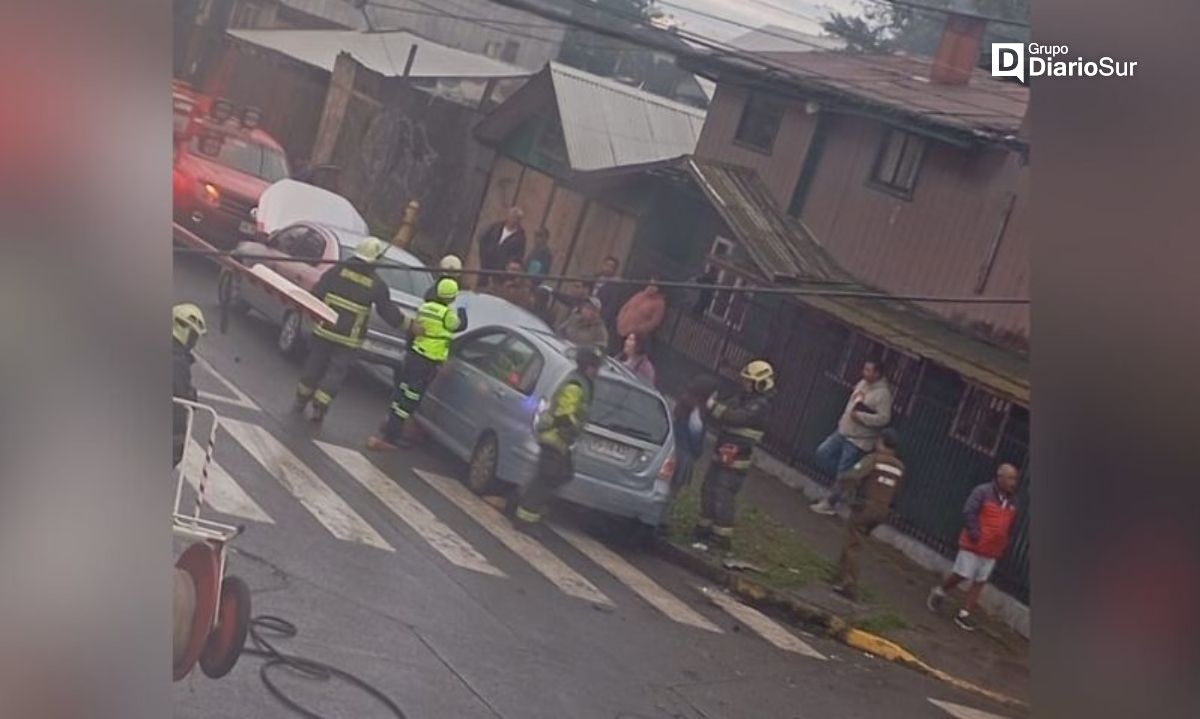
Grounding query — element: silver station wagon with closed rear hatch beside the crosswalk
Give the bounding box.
[415,316,676,528]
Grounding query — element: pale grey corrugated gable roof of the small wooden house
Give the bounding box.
[550,62,706,172]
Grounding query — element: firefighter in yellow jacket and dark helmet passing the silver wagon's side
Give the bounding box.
[512,346,605,531]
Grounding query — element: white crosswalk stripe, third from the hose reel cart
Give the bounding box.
[316,442,504,576]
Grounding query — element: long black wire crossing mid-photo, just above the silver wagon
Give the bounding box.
[174,247,1030,305]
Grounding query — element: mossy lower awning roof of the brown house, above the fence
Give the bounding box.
[685,158,1030,406]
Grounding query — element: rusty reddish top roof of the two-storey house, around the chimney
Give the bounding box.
[734,50,1030,139]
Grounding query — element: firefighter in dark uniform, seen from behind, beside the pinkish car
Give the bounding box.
[293,238,408,423]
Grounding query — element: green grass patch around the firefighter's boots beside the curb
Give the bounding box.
[667,472,835,589]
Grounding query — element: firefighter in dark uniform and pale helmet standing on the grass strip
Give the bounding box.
[692,360,775,551]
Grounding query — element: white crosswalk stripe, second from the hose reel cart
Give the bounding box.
[221,418,395,552]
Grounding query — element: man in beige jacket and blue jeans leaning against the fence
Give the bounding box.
[811,360,892,515]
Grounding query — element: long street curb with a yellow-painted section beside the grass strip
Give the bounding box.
[653,538,1028,709]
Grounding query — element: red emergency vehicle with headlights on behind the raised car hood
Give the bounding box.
[172,95,289,250]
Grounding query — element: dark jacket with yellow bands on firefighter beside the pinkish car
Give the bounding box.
[312,258,404,349]
